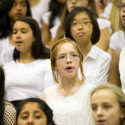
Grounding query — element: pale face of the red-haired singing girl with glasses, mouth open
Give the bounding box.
[56,43,80,79]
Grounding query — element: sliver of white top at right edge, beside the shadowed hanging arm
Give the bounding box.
[119,47,125,94]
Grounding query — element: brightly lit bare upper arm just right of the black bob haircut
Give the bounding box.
[96,28,110,51]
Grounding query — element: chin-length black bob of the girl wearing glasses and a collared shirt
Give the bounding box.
[64,7,100,44]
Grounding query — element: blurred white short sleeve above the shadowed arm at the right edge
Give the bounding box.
[109,30,125,50]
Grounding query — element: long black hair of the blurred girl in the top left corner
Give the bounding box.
[0,0,31,38]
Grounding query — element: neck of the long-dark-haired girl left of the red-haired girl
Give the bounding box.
[18,53,36,63]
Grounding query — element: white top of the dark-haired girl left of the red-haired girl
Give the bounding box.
[3,59,54,101]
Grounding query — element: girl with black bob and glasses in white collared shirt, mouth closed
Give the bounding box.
[64,7,111,85]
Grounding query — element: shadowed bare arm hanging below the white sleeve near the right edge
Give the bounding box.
[108,49,121,86]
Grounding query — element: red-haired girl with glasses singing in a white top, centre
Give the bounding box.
[40,38,94,125]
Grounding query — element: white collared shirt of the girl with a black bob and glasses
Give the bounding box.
[82,45,111,86]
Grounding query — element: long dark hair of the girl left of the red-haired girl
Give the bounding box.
[13,17,50,61]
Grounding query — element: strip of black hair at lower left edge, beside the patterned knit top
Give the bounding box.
[0,67,5,125]
